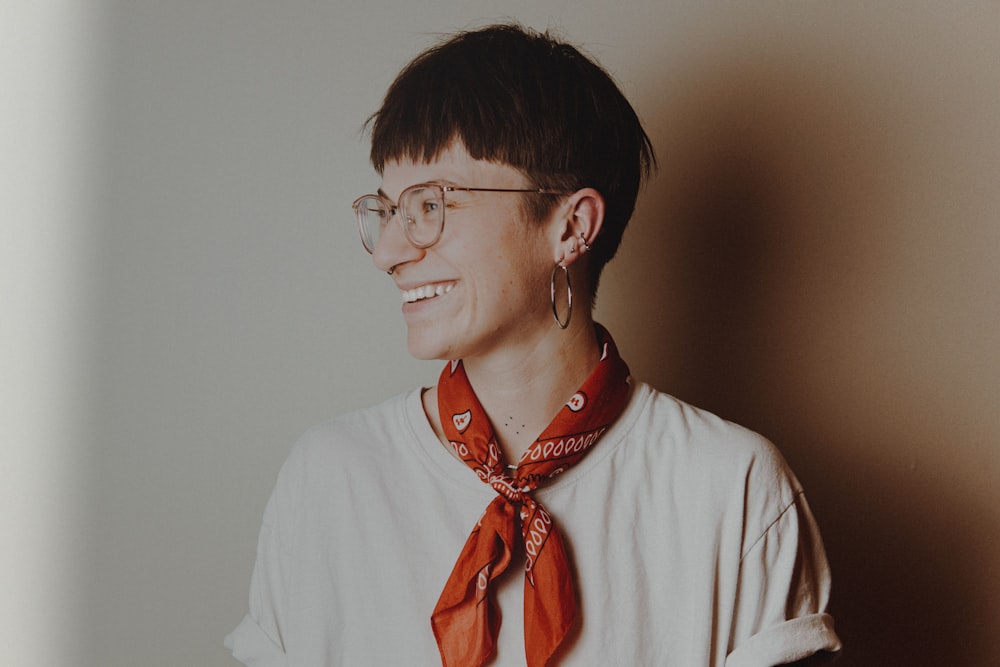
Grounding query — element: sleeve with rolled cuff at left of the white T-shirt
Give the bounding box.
[225,496,287,667]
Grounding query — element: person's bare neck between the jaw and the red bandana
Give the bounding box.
[424,309,600,463]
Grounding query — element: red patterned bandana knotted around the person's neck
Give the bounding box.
[431,325,631,667]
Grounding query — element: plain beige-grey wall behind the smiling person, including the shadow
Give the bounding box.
[0,0,1000,667]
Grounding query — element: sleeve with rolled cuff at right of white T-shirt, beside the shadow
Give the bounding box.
[726,490,841,667]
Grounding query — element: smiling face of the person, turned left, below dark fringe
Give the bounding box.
[372,145,555,360]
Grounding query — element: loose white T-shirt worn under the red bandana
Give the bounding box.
[226,384,840,667]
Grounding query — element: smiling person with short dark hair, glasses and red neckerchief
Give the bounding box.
[226,25,840,667]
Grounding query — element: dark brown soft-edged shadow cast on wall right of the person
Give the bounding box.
[601,39,1000,667]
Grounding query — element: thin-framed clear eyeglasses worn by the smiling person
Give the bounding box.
[352,183,572,253]
